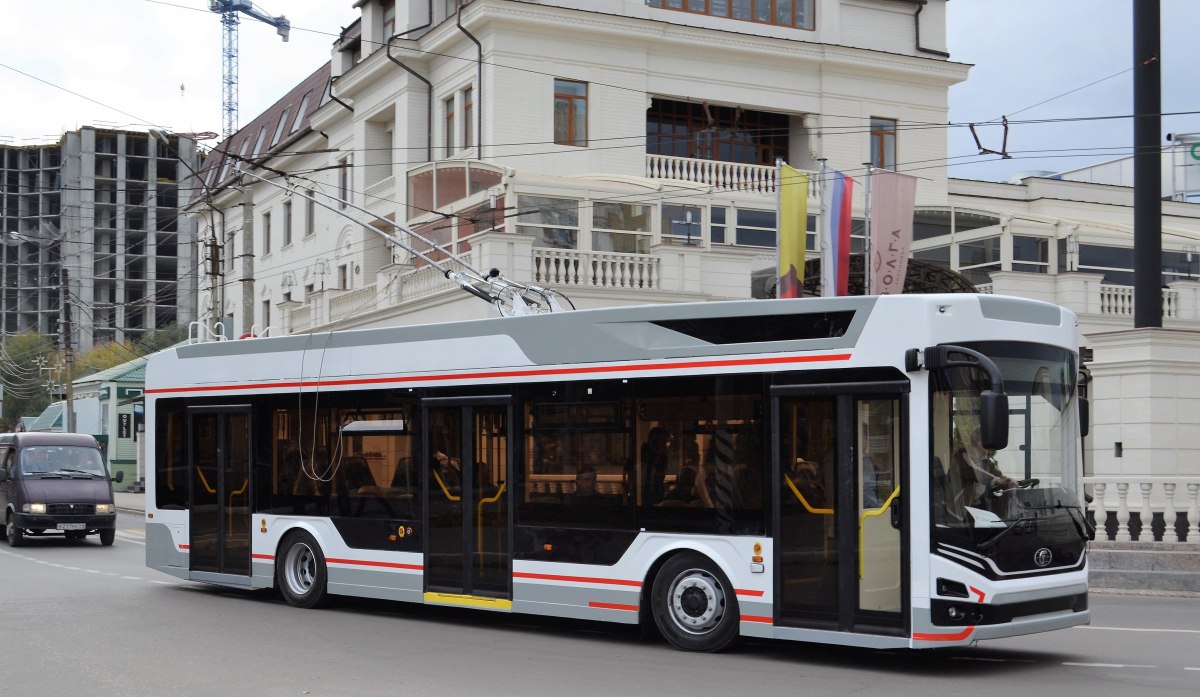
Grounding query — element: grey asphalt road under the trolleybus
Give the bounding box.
[0,513,1200,697]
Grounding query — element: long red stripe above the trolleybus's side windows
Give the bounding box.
[146,354,851,395]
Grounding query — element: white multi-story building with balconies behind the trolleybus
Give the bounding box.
[191,0,1200,537]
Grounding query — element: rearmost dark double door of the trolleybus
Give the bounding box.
[187,407,251,584]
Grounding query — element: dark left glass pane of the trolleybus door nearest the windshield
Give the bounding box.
[779,398,839,621]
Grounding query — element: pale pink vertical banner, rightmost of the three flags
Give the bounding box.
[868,169,917,295]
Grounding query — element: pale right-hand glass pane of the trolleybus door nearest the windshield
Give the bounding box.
[854,399,901,612]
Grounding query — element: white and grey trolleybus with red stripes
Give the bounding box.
[146,294,1092,650]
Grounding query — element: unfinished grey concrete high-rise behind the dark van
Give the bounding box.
[0,126,199,350]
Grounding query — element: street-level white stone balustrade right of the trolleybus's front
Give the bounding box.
[1084,476,1200,543]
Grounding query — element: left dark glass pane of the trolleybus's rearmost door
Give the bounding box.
[190,414,221,572]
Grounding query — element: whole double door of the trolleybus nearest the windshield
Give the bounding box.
[773,384,908,635]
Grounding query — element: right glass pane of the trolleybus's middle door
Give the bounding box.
[473,407,510,594]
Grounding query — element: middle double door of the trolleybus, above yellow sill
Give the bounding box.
[422,397,512,601]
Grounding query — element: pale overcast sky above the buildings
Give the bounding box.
[0,0,1200,181]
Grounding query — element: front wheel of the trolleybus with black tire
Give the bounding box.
[650,552,742,653]
